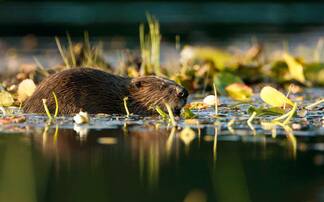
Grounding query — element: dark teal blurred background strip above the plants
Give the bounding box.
[0,0,324,37]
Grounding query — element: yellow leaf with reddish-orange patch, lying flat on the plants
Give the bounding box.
[225,83,253,101]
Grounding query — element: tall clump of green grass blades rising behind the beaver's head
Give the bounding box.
[139,14,162,75]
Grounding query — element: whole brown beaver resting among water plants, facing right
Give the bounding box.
[23,67,188,116]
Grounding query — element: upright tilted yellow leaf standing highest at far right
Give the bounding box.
[283,53,305,83]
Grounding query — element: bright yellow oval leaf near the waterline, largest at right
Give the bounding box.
[260,86,294,107]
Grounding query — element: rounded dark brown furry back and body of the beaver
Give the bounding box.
[23,68,130,114]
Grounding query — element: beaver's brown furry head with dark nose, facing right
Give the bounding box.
[129,76,188,115]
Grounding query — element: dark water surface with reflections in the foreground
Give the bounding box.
[0,124,324,202]
